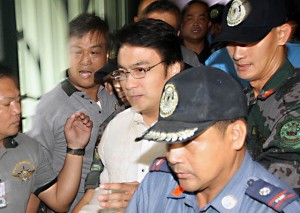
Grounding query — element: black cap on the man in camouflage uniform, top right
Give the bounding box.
[213,0,288,46]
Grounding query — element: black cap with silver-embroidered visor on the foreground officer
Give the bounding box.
[136,66,247,143]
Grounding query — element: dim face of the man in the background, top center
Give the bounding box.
[181,4,211,41]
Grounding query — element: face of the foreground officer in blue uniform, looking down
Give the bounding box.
[167,126,234,193]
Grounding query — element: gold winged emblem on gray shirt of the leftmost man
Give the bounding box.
[12,161,35,182]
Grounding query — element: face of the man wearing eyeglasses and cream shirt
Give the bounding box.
[118,45,169,115]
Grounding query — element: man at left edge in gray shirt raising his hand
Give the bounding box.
[0,65,93,213]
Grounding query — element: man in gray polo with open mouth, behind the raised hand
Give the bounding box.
[28,14,118,209]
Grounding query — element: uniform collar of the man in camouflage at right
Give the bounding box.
[245,59,295,102]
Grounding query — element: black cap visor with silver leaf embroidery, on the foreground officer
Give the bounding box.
[135,120,216,143]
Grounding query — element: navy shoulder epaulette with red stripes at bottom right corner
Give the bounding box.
[246,179,299,212]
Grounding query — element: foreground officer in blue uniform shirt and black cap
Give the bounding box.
[126,67,300,213]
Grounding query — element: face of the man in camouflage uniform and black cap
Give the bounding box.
[227,29,282,81]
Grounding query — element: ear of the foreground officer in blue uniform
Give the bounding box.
[229,120,247,150]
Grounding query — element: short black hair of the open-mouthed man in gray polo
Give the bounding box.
[69,13,110,48]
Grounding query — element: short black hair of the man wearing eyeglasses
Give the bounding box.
[116,19,183,66]
